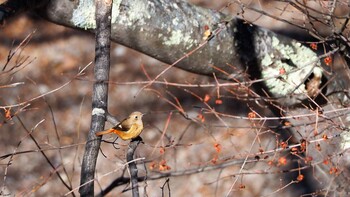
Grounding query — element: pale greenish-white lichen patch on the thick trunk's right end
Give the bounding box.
[261,36,322,96]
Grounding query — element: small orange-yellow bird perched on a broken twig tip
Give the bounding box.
[95,111,143,140]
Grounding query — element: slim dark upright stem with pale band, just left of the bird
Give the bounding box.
[79,0,111,196]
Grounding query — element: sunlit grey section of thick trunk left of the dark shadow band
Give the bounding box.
[42,0,240,77]
